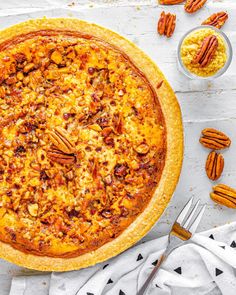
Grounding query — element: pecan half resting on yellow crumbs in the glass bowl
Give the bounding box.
[192,35,218,67]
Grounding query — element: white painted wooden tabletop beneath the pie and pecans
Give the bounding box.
[0,0,236,295]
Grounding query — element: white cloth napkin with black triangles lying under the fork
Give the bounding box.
[10,222,236,295]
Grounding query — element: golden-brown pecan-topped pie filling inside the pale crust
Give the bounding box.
[0,30,166,257]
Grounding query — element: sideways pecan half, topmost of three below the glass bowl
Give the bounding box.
[199,128,231,150]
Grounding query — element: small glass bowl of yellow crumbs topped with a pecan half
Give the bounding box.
[178,25,232,80]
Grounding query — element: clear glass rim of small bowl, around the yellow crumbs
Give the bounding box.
[177,25,233,80]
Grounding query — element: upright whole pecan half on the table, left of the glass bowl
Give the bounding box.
[157,11,176,38]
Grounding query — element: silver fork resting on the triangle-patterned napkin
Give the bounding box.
[137,198,206,295]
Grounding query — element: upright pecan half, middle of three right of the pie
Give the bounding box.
[205,151,224,180]
